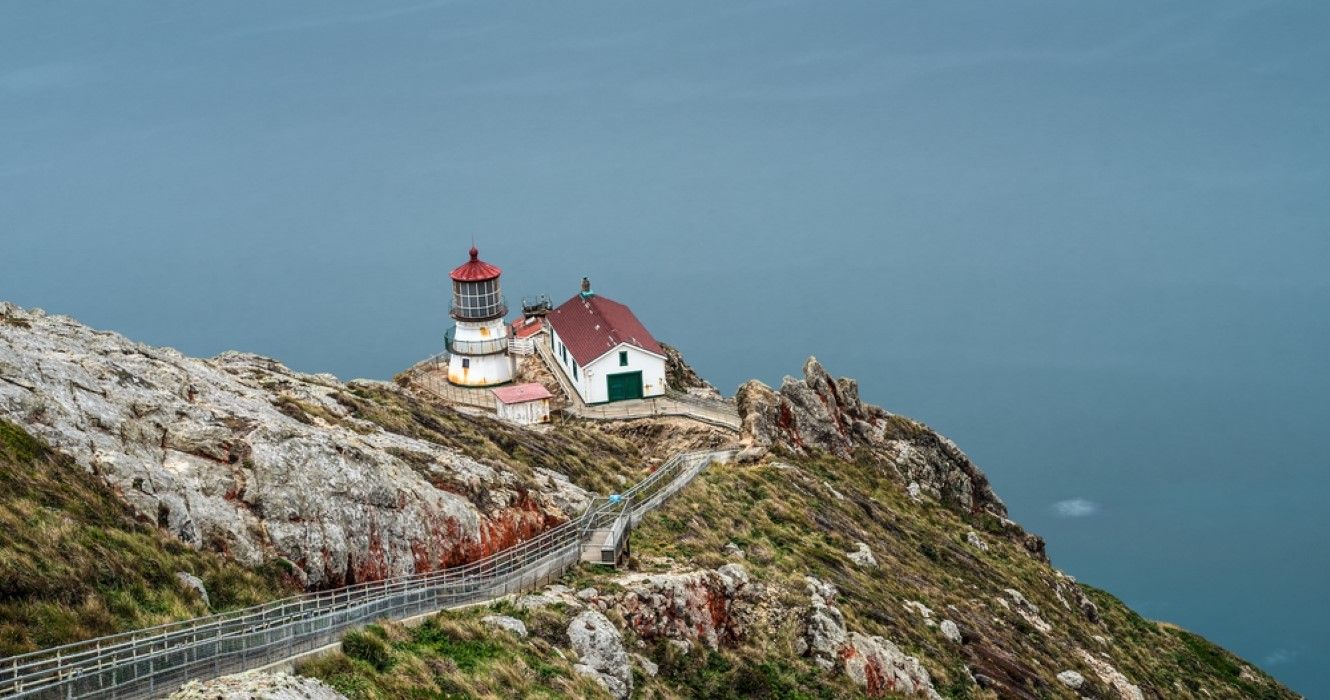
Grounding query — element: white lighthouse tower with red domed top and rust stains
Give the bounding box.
[444,246,513,386]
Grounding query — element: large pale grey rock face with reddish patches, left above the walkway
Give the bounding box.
[0,302,587,587]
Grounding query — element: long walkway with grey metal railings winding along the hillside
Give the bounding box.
[0,450,734,697]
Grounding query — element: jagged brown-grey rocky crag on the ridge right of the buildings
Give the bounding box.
[735,358,1007,518]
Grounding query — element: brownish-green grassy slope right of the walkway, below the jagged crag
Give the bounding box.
[617,459,1295,699]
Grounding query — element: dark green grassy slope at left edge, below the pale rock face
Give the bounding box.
[0,421,294,656]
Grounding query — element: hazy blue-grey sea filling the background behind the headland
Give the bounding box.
[0,1,1330,696]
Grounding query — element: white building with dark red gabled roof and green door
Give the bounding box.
[545,279,665,403]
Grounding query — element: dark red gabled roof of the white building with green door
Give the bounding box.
[545,294,665,367]
